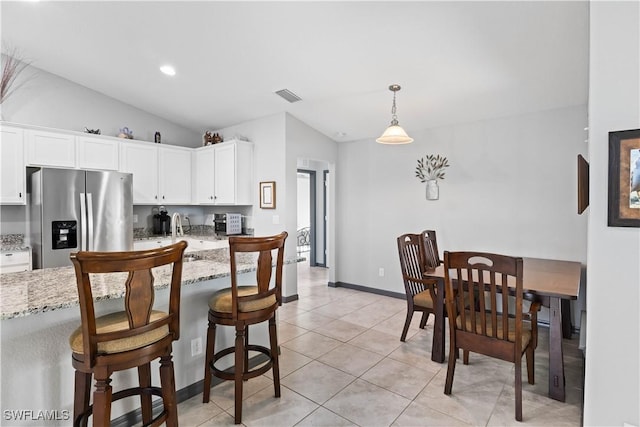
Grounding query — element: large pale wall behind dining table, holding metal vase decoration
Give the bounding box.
[336,106,587,322]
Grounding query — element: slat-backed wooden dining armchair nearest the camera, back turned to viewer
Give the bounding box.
[444,251,540,421]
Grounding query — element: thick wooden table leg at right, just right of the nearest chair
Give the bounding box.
[549,297,565,402]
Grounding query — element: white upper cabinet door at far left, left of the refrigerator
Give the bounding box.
[0,126,27,205]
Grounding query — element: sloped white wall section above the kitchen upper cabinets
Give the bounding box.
[2,60,204,147]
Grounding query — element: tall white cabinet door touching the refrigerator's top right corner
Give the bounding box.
[120,142,159,204]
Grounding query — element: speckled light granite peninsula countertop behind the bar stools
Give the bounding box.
[0,248,303,320]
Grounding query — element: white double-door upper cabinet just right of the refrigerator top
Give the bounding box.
[120,142,191,204]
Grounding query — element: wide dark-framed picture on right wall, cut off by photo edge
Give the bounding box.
[607,129,640,227]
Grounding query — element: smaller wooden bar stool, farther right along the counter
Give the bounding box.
[202,232,287,424]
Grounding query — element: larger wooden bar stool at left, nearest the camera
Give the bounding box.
[69,241,187,426]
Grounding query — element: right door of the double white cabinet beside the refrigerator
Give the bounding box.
[158,146,191,204]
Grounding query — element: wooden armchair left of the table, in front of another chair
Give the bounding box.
[397,234,436,342]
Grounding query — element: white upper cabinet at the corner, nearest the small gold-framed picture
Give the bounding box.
[194,140,253,205]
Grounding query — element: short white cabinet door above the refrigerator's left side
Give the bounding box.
[25,130,76,168]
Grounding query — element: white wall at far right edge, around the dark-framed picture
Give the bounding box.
[584,2,640,426]
